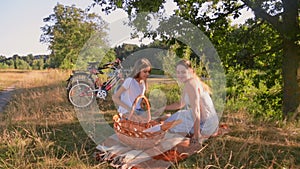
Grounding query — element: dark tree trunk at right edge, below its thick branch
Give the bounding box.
[282,38,300,118]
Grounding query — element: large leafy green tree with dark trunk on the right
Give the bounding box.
[91,0,300,118]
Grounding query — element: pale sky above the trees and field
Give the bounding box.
[0,0,253,57]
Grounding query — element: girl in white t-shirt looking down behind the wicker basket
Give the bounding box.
[112,58,151,121]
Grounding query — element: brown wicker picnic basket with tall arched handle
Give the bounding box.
[113,96,165,149]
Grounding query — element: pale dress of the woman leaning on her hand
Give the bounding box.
[166,84,219,135]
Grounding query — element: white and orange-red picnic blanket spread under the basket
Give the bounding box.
[95,125,229,169]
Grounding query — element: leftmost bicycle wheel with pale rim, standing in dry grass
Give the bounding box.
[68,82,96,108]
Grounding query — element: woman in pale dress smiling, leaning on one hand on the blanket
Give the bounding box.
[160,60,219,143]
